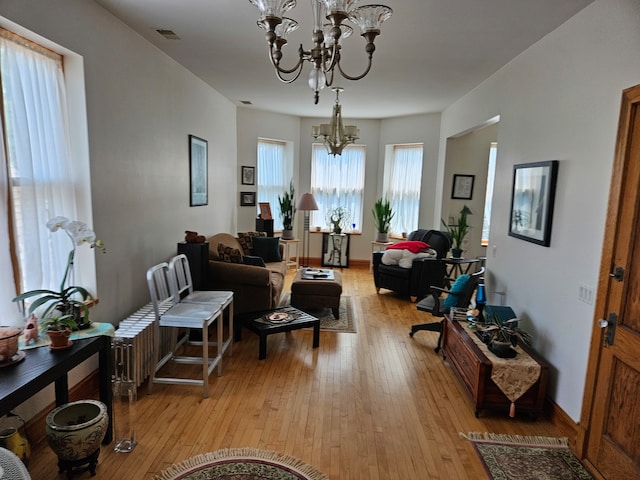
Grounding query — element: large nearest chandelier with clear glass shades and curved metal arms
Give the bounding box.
[249,0,393,103]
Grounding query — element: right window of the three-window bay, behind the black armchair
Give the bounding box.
[383,143,424,235]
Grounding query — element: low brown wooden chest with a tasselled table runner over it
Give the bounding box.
[442,317,549,418]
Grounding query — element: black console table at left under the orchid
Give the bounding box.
[0,335,113,445]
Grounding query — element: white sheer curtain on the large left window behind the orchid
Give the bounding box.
[0,32,76,302]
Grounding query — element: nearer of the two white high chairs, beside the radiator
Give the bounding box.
[147,262,222,398]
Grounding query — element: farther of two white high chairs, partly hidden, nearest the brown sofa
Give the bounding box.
[169,254,233,362]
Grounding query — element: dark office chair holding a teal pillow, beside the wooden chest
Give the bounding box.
[409,267,484,353]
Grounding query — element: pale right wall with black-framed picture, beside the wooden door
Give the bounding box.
[440,0,640,421]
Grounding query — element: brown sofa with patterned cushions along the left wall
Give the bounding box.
[207,232,287,314]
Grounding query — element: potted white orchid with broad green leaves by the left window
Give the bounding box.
[13,217,106,330]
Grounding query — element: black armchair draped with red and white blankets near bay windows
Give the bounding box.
[372,229,451,302]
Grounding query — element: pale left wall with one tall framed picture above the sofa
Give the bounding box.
[0,0,237,418]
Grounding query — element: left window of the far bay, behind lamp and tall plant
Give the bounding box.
[257,138,292,230]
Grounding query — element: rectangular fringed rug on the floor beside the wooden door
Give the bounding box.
[460,432,593,480]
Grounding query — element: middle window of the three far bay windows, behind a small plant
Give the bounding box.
[310,144,365,232]
